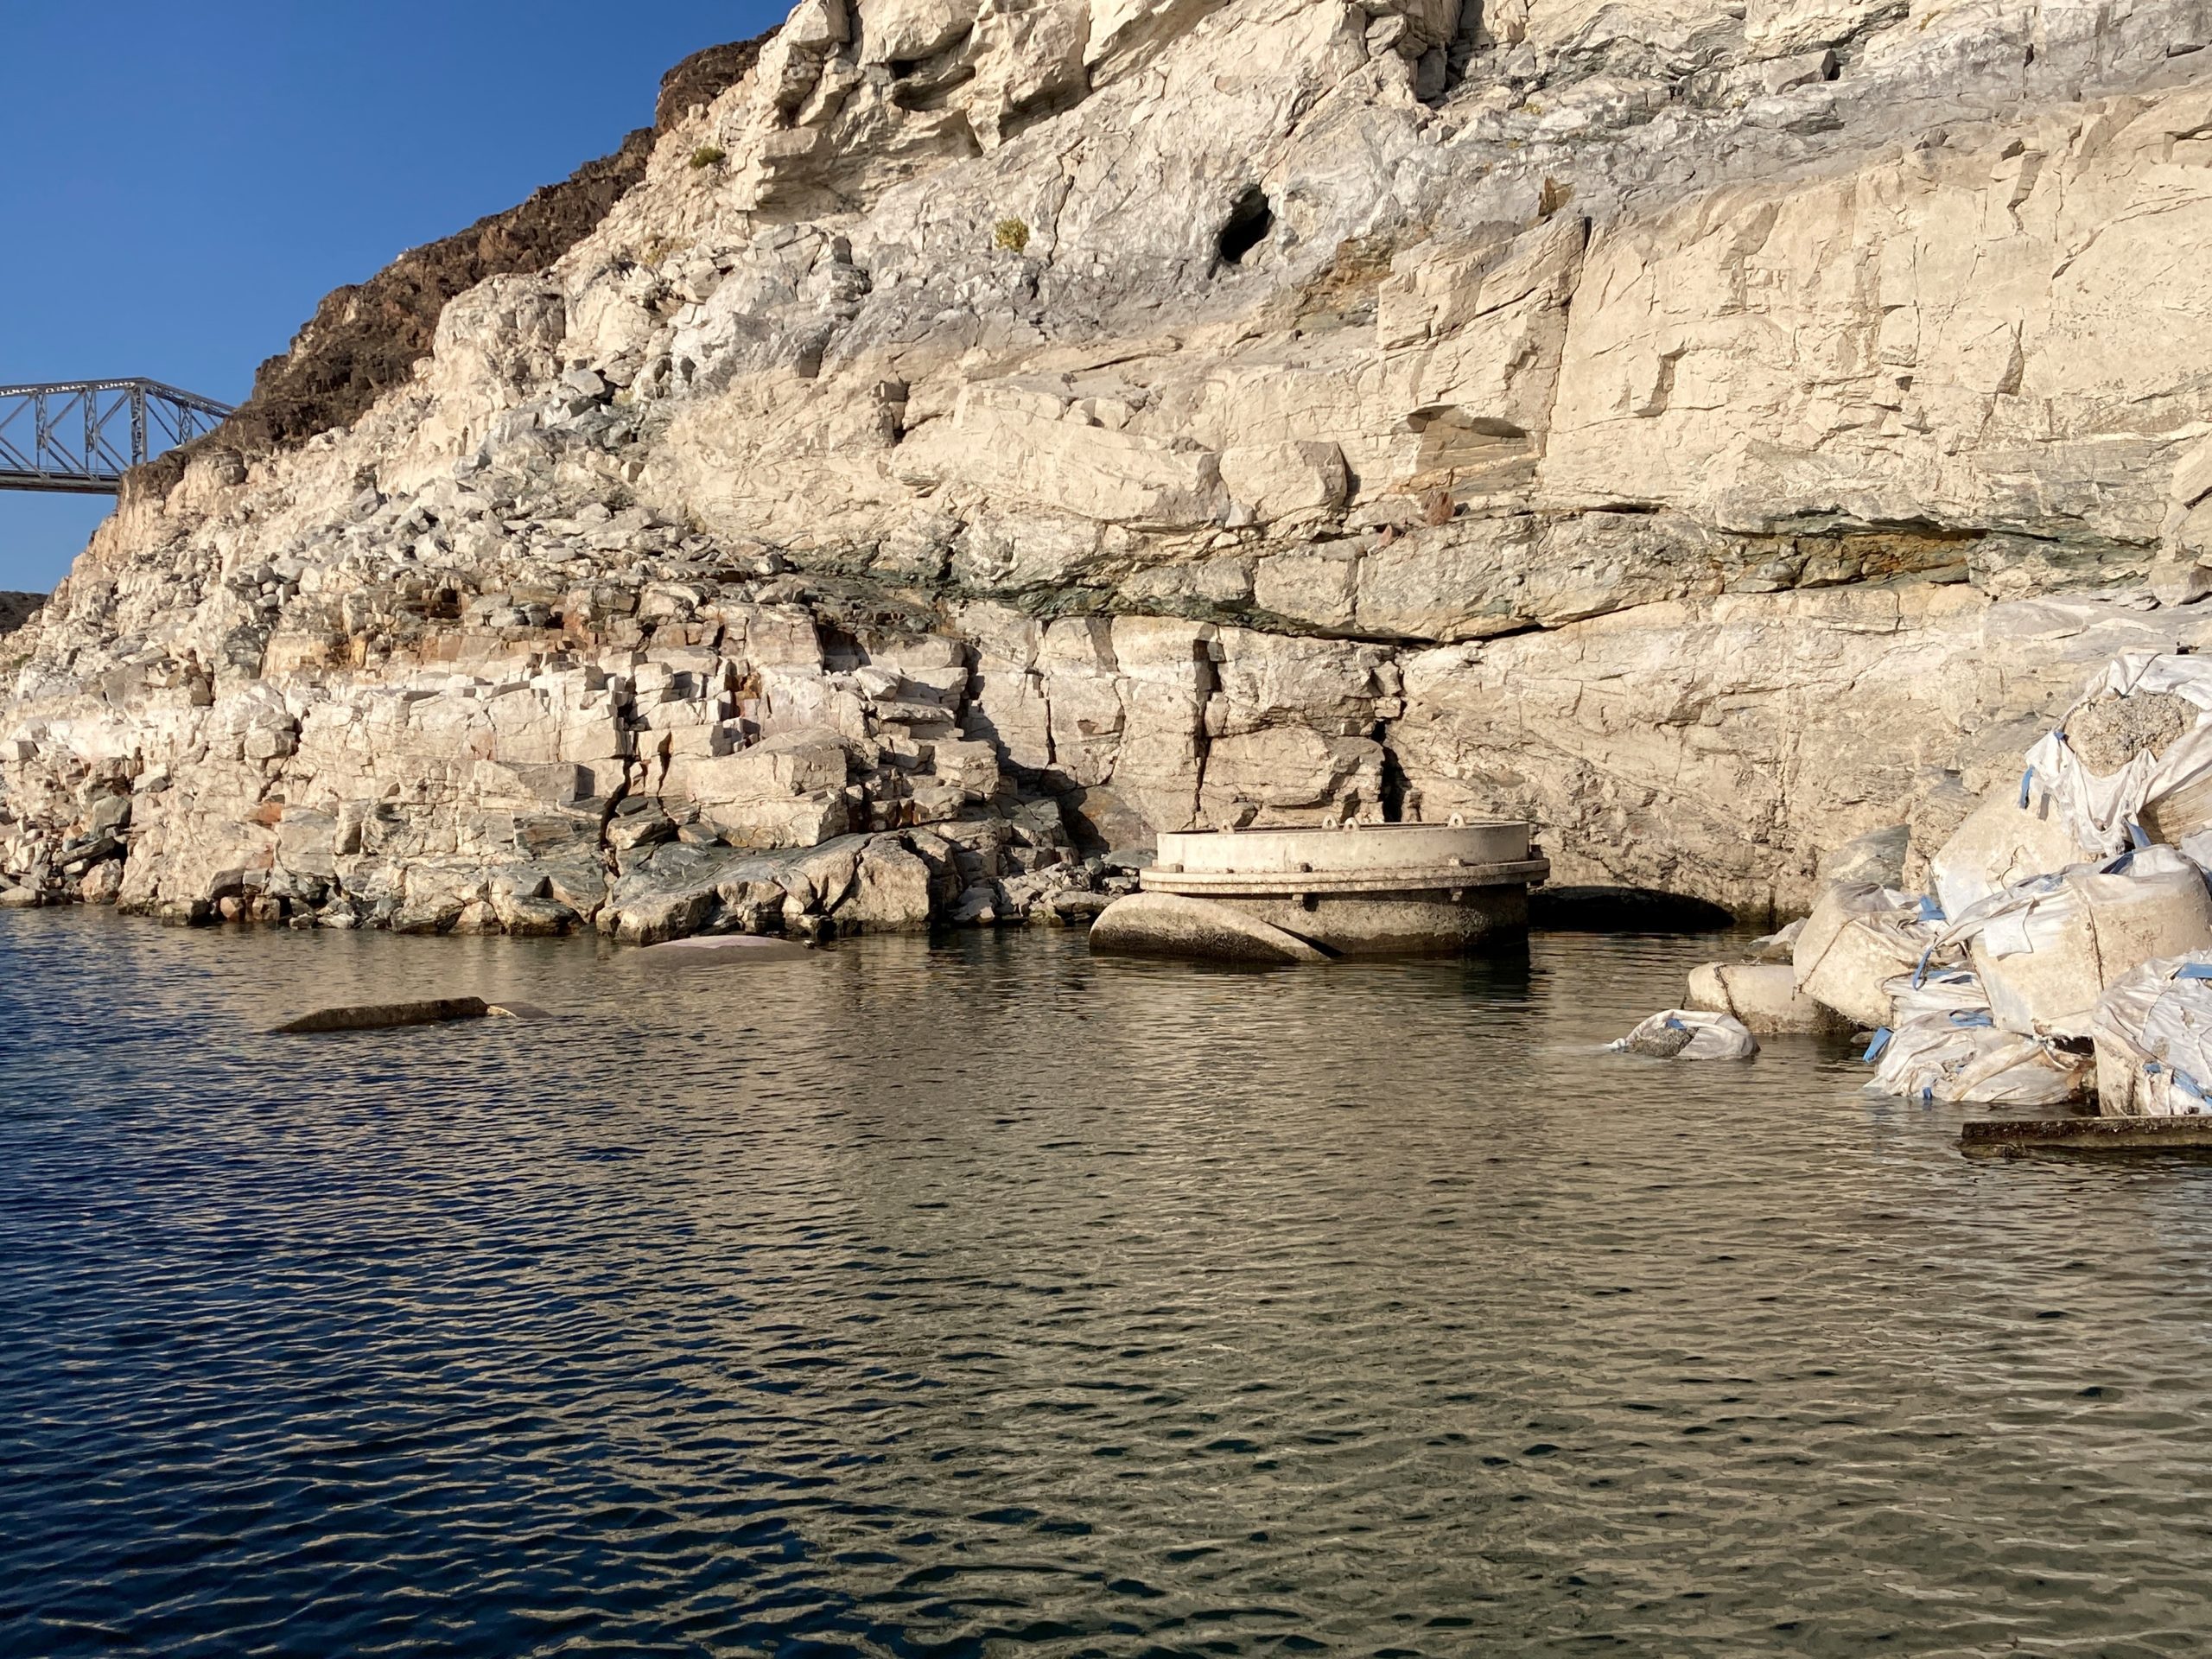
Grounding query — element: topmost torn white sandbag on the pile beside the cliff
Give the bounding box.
[2022,651,2212,856]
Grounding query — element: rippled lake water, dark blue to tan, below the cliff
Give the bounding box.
[0,912,2212,1659]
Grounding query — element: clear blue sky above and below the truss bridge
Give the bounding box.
[0,0,787,591]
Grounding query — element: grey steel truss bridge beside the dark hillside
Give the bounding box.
[0,380,230,495]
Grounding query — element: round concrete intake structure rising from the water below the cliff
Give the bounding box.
[1093,823,1551,956]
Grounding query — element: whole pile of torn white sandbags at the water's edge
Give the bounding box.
[1822,652,2212,1110]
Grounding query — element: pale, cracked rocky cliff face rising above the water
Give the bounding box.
[0,0,2212,938]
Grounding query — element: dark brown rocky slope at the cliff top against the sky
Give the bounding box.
[163,35,767,480]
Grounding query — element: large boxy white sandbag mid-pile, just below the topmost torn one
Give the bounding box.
[1942,847,2212,1038]
